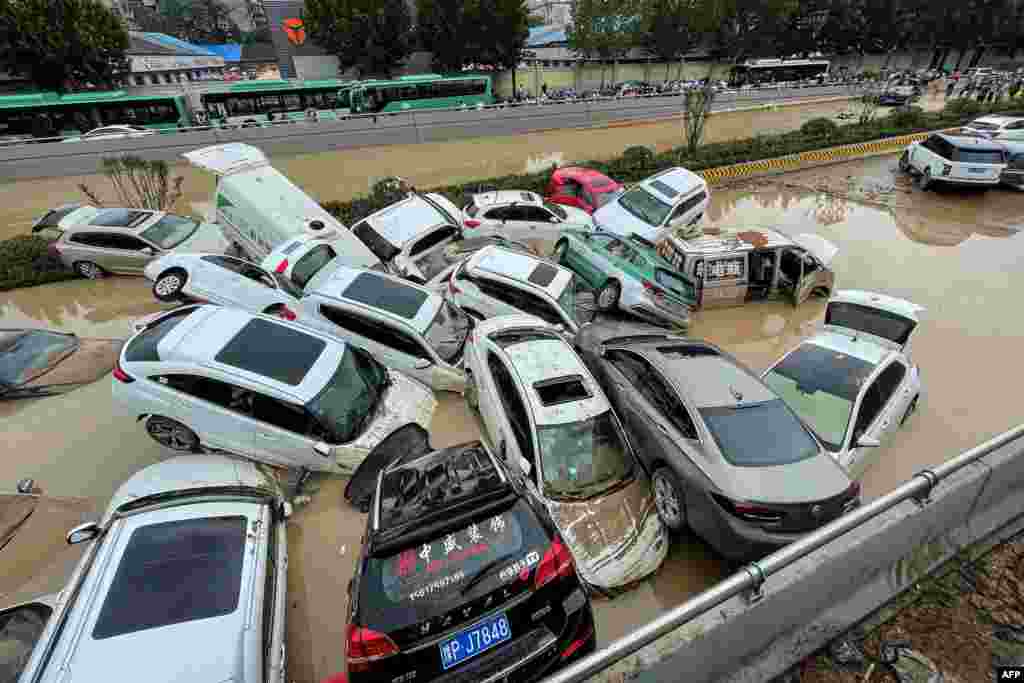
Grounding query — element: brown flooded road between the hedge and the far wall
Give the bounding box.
[0,93,938,240]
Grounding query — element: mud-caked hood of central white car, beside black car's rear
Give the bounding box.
[547,468,668,588]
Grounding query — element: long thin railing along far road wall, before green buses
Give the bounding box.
[0,83,849,147]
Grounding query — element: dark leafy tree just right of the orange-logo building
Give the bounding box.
[304,0,413,77]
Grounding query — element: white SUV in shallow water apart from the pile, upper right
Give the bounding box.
[899,133,1007,189]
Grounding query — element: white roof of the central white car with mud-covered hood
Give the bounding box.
[504,337,608,426]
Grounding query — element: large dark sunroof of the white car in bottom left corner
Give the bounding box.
[92,516,247,640]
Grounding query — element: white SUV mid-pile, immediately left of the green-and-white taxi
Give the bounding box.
[447,247,596,337]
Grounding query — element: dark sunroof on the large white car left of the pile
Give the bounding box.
[214,318,327,386]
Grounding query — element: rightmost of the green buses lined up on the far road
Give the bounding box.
[345,74,495,114]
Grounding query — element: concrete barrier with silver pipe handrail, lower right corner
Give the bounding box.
[544,425,1024,683]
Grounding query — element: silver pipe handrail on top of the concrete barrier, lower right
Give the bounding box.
[543,424,1024,683]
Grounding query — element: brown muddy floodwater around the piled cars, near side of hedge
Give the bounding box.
[0,150,1024,683]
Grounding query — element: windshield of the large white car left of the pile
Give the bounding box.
[306,346,390,443]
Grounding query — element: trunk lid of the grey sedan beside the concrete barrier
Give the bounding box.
[715,451,850,505]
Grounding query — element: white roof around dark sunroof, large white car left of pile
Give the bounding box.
[150,305,346,403]
